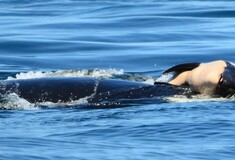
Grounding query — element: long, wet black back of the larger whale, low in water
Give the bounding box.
[0,77,190,103]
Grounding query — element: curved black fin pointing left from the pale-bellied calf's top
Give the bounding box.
[163,63,201,75]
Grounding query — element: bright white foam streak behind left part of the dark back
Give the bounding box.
[7,69,124,80]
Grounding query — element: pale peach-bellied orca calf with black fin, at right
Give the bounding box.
[163,60,235,97]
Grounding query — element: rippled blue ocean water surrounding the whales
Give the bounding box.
[0,0,235,160]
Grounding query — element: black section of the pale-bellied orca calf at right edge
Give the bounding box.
[216,62,235,97]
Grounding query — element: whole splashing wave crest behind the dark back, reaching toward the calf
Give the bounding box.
[6,69,158,84]
